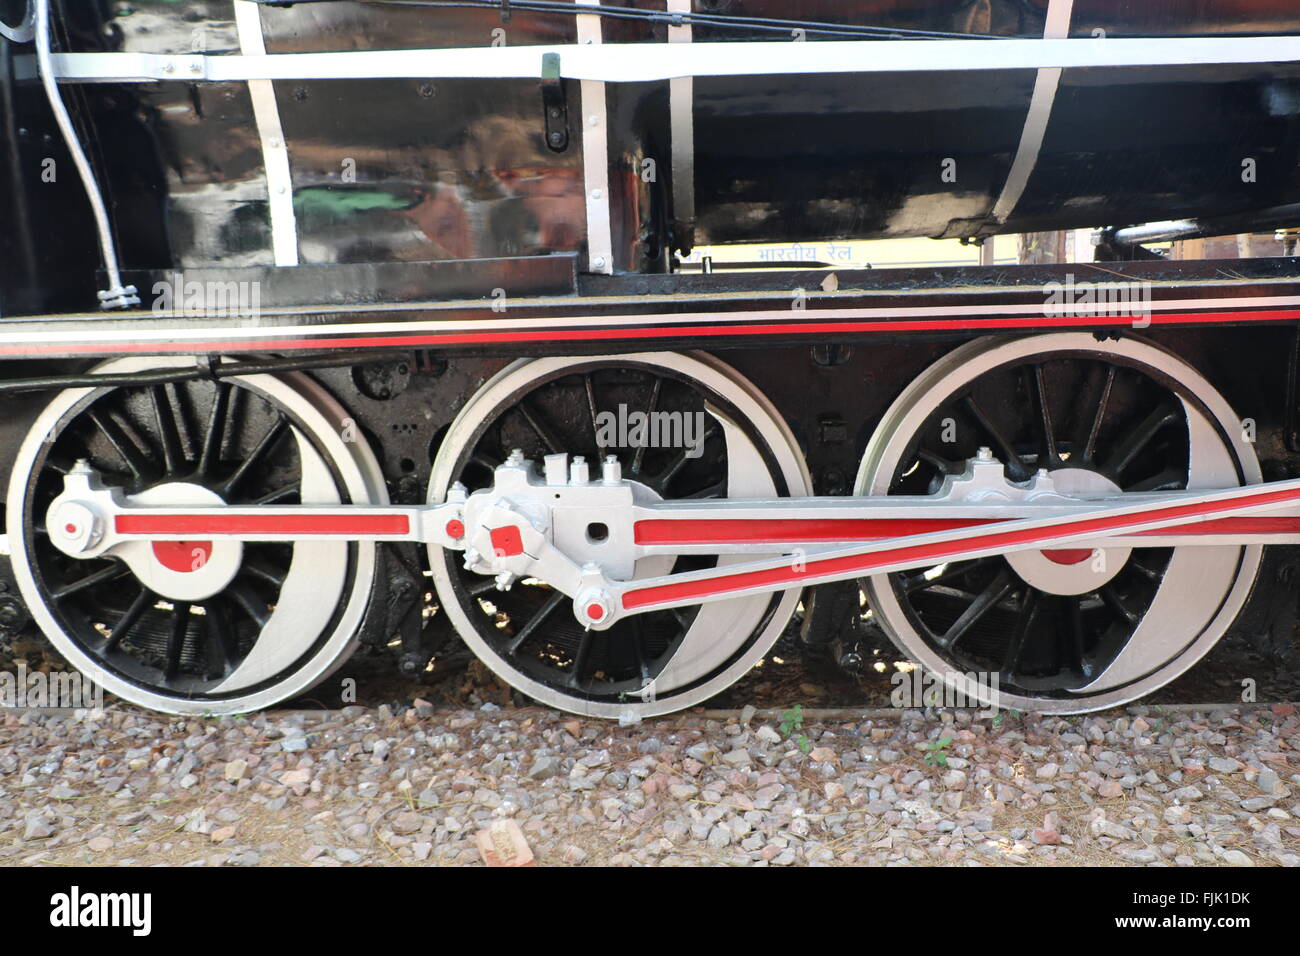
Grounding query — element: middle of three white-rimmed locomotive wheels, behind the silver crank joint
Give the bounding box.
[429,354,811,718]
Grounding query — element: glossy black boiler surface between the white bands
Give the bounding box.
[0,0,1300,315]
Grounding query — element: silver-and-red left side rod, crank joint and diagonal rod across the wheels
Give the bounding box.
[46,455,1300,630]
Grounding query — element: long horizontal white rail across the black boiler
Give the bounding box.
[53,36,1300,83]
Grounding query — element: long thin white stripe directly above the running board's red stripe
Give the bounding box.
[0,295,1300,346]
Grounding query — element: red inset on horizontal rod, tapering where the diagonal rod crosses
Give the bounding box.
[633,518,1008,545]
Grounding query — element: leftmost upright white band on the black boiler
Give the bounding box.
[235,0,298,265]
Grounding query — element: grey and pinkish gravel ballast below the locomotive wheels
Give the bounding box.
[0,704,1300,866]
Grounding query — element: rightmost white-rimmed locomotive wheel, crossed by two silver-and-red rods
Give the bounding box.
[857,333,1262,713]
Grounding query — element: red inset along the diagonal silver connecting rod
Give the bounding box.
[623,490,1300,610]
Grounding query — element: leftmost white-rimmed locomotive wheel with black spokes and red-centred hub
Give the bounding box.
[7,359,387,714]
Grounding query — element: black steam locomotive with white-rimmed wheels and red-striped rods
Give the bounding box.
[0,0,1300,718]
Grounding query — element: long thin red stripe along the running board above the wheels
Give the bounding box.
[0,310,1300,355]
